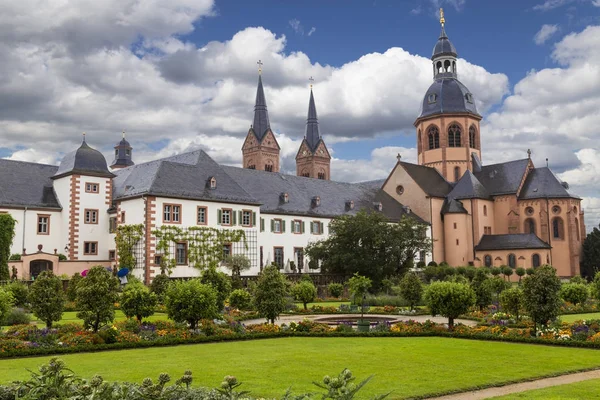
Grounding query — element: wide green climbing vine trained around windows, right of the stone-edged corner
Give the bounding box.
[152,225,248,273]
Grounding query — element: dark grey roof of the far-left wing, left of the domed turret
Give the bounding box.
[0,159,61,208]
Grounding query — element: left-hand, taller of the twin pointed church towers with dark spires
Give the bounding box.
[242,61,281,172]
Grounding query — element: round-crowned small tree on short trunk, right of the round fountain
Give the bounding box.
[425,282,476,331]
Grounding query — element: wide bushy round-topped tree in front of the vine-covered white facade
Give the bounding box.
[165,279,219,329]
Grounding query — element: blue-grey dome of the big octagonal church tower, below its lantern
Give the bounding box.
[419,78,479,118]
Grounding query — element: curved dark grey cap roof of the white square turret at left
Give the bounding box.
[53,139,114,179]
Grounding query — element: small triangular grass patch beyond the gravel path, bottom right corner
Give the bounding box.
[494,379,600,400]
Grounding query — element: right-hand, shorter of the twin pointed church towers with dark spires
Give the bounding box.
[296,82,331,180]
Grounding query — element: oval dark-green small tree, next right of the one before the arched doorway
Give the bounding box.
[77,265,119,332]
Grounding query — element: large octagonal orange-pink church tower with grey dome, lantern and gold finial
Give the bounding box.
[414,9,481,182]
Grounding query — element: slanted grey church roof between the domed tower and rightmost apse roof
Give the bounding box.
[475,159,529,196]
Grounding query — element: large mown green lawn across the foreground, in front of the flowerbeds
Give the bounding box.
[0,338,600,398]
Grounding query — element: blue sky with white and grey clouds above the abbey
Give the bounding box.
[0,0,600,229]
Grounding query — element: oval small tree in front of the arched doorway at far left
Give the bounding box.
[28,271,65,328]
